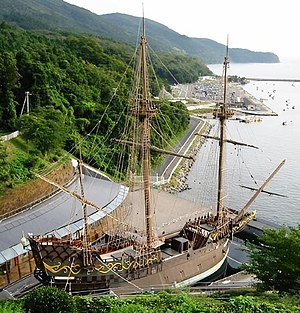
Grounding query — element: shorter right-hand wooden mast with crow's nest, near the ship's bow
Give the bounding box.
[214,42,233,226]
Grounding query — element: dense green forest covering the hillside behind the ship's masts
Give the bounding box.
[0,23,211,194]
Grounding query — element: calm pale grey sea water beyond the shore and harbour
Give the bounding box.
[181,59,300,226]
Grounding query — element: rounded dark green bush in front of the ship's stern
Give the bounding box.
[23,287,75,313]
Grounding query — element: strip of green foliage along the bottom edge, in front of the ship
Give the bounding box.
[0,287,300,313]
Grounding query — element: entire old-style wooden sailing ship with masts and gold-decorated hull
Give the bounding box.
[27,23,284,294]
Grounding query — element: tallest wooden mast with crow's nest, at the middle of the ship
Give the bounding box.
[132,18,158,247]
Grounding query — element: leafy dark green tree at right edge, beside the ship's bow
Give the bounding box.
[245,225,300,292]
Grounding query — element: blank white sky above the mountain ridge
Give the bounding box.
[64,0,300,59]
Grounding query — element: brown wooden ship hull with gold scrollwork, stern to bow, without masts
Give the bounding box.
[29,208,255,294]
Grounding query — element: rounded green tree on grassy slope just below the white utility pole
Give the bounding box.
[20,106,68,154]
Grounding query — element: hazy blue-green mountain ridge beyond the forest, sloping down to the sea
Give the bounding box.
[0,0,279,64]
